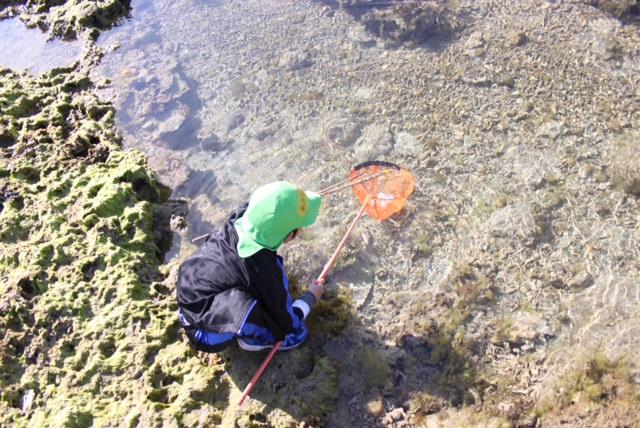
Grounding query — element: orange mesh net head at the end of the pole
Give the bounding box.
[349,161,415,220]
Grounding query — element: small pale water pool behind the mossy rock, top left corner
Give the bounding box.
[0,18,82,74]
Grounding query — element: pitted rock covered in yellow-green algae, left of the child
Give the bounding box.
[0,65,210,426]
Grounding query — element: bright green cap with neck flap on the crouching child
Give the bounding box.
[235,181,321,258]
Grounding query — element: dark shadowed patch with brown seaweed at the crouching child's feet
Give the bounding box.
[194,280,487,426]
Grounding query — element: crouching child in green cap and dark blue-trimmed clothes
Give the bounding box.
[177,181,322,352]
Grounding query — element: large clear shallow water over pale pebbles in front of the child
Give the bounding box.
[5,0,640,422]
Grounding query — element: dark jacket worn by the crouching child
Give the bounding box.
[177,205,304,340]
